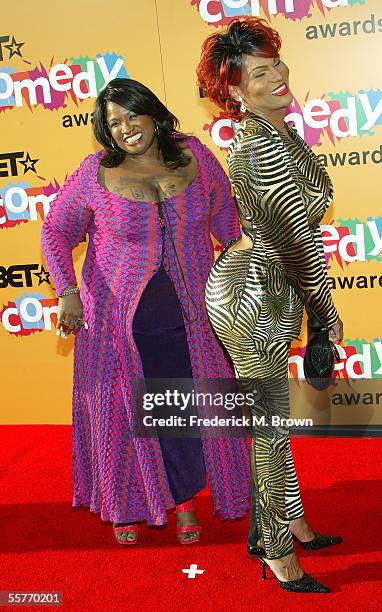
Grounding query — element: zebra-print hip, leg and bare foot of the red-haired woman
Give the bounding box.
[206,249,334,588]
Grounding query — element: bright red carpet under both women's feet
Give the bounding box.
[0,426,382,612]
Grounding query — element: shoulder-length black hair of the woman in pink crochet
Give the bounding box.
[93,79,190,169]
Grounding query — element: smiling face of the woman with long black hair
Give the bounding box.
[106,102,157,156]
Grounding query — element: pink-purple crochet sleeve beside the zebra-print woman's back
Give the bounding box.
[206,147,240,246]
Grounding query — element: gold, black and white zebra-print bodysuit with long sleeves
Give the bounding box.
[206,113,338,559]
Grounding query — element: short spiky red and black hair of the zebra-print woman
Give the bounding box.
[196,17,281,119]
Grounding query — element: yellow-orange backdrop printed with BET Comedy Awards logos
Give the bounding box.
[0,0,382,426]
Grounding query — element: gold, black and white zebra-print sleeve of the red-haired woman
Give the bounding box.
[230,133,338,326]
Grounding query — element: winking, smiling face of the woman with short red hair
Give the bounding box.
[229,53,293,115]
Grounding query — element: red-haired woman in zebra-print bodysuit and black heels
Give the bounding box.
[198,17,342,592]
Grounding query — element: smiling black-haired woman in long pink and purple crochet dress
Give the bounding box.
[42,79,249,544]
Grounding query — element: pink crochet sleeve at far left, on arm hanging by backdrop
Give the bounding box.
[41,155,92,294]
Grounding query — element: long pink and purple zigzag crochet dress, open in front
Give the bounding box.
[42,137,249,525]
